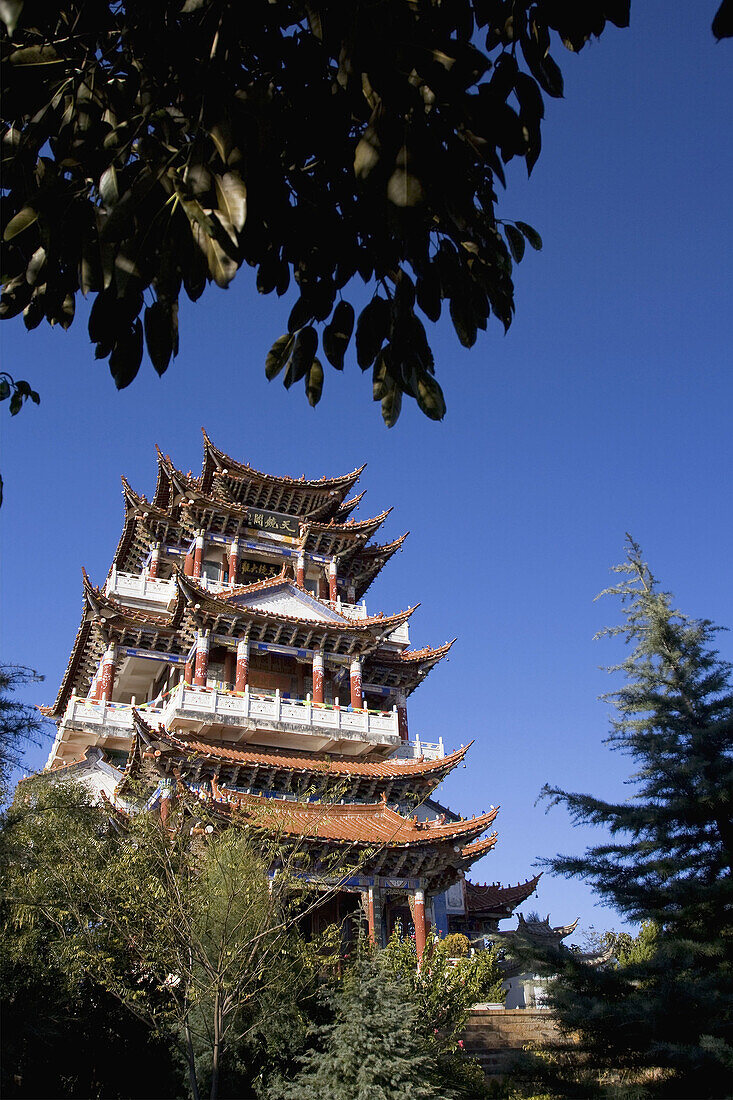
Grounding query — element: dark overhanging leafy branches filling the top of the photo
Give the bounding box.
[0,0,630,425]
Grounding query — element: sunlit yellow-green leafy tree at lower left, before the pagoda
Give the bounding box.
[4,779,343,1100]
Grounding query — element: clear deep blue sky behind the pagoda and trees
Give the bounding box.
[0,0,733,928]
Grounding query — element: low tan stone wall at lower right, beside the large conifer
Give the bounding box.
[463,1009,560,1076]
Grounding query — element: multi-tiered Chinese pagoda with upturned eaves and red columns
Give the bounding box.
[42,432,537,954]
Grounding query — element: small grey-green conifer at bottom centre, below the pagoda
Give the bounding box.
[269,954,448,1100]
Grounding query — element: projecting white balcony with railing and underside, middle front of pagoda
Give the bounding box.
[163,683,401,756]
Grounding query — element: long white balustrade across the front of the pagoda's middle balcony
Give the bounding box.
[163,684,400,746]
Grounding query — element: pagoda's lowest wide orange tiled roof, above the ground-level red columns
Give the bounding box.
[211,780,499,853]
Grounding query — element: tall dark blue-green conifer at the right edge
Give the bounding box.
[544,538,733,1097]
